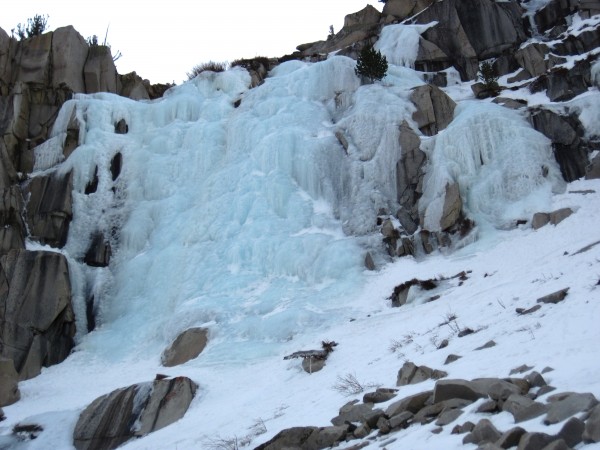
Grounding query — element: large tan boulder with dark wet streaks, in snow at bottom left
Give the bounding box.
[73,377,198,450]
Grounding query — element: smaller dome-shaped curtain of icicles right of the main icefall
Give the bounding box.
[419,101,564,231]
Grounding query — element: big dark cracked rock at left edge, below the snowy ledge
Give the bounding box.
[0,250,75,380]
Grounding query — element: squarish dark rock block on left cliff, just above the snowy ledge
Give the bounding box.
[25,172,73,248]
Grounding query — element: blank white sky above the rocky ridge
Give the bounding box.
[0,0,383,83]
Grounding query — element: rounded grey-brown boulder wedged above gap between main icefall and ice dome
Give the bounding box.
[410,84,456,136]
